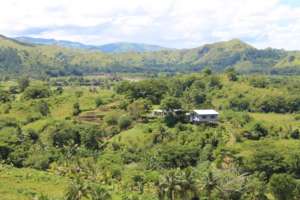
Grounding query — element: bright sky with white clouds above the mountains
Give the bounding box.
[0,0,300,50]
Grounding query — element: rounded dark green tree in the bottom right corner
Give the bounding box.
[269,174,297,200]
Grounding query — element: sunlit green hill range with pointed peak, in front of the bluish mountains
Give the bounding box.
[0,36,300,76]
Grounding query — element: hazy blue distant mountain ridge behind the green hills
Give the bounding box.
[14,37,167,53]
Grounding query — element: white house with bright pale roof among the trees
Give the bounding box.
[188,110,219,123]
